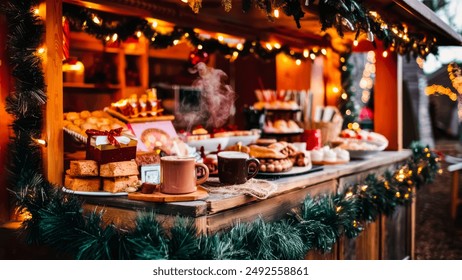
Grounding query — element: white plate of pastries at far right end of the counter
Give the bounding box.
[334,129,388,159]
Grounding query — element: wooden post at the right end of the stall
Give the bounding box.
[374,51,403,151]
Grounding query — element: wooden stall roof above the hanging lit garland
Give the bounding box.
[68,0,462,45]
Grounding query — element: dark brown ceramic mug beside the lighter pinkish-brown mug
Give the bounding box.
[218,151,260,185]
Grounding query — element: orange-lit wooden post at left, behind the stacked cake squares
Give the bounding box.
[40,0,64,184]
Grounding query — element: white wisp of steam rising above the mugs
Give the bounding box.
[178,62,236,129]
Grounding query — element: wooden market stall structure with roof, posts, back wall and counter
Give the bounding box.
[0,0,462,259]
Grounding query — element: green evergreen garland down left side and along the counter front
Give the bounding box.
[2,0,441,260]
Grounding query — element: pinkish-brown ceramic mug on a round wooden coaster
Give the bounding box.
[160,156,209,194]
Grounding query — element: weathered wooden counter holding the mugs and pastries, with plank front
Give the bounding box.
[84,150,414,259]
